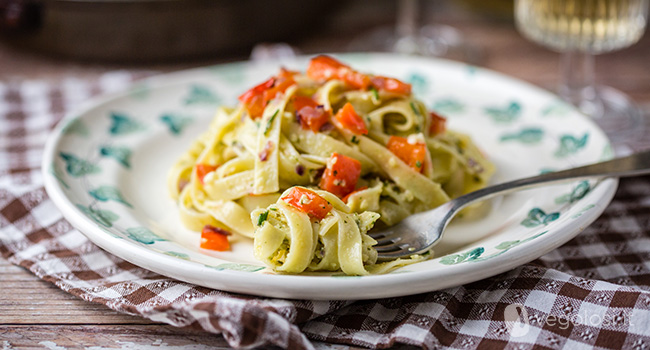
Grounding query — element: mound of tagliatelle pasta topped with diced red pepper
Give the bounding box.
[168,56,493,275]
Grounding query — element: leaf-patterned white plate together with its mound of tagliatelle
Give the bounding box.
[43,54,617,299]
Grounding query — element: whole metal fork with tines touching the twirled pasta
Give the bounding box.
[370,151,650,261]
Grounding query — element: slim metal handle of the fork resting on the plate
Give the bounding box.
[454,151,650,209]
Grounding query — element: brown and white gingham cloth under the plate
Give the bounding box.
[0,72,650,349]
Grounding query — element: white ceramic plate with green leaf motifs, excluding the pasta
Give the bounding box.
[43,54,617,299]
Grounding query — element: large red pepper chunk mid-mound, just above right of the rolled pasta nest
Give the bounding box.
[318,153,361,198]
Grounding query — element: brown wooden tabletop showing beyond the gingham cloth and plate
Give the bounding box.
[0,1,650,350]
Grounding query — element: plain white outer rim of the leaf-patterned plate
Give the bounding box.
[41,53,618,300]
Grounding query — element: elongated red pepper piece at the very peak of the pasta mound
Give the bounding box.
[307,55,370,90]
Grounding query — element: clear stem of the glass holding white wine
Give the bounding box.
[559,51,603,118]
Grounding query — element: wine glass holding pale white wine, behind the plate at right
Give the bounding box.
[515,0,649,153]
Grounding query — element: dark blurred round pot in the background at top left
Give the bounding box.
[0,0,340,62]
